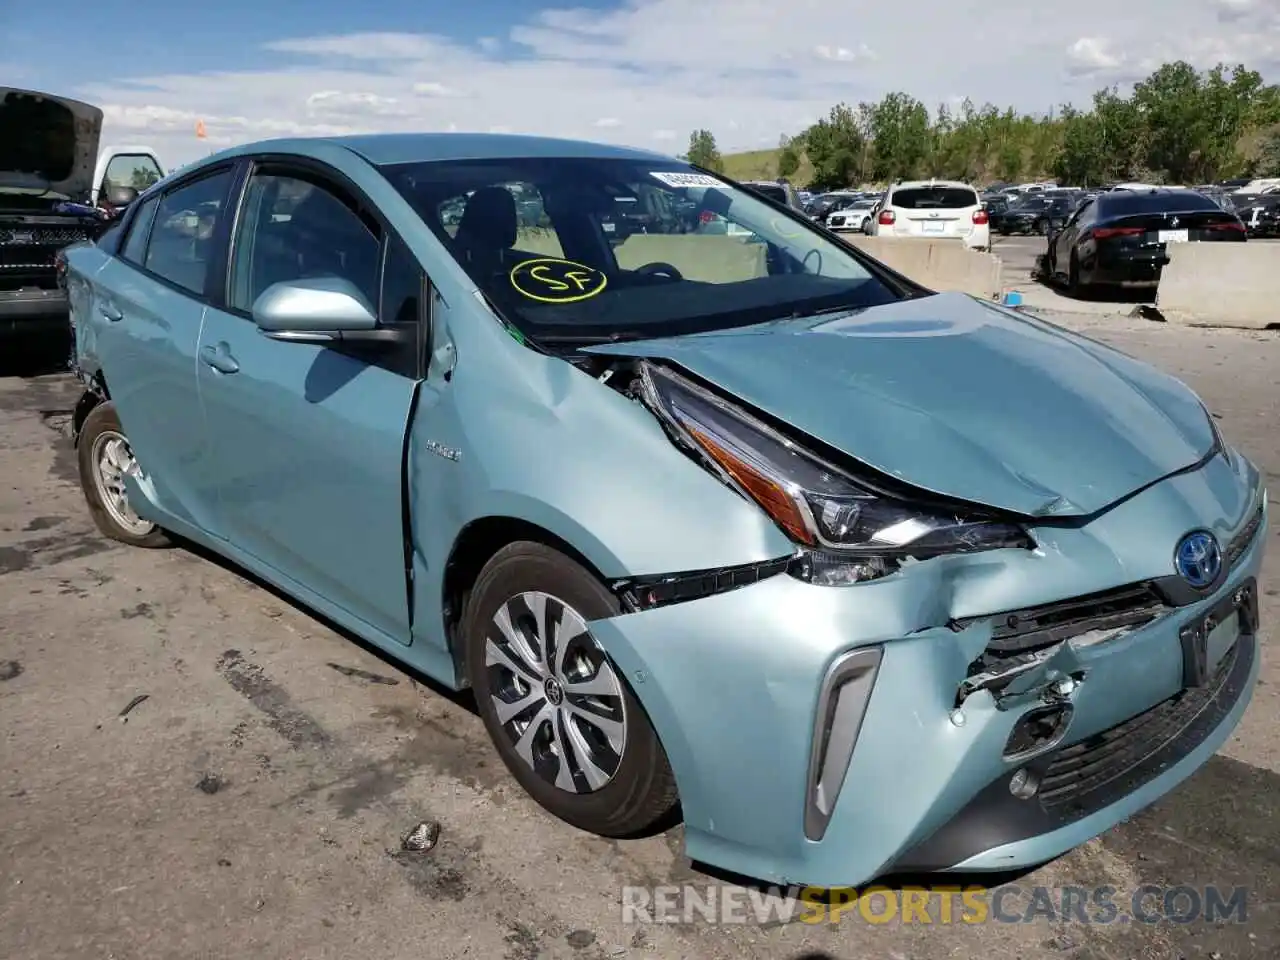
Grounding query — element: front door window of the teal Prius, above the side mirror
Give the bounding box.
[228,173,380,314]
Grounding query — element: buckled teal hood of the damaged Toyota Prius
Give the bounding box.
[586,293,1215,516]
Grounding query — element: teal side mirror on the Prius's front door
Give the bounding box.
[252,276,406,343]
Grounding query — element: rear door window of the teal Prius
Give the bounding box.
[143,170,232,296]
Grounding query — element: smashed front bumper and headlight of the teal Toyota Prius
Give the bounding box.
[558,343,1265,886]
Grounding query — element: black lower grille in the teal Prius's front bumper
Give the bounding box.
[1039,636,1253,810]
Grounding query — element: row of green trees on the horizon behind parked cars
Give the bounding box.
[737,61,1280,188]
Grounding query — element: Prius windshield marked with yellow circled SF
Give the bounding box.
[380,157,901,340]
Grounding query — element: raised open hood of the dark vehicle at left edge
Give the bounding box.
[0,87,102,200]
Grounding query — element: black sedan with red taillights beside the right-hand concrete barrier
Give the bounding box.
[1044,189,1248,296]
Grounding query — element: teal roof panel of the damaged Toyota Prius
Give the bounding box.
[202,133,672,166]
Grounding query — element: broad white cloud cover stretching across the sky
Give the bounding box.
[57,0,1280,163]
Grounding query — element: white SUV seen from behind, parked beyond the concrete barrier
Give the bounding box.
[870,180,991,250]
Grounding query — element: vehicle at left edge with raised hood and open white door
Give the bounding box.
[0,87,164,338]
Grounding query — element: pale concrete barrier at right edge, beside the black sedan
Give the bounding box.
[1156,242,1280,330]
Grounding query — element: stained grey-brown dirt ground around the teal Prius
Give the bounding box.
[0,323,1280,960]
